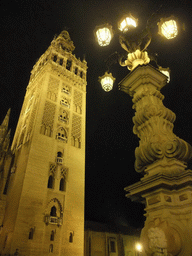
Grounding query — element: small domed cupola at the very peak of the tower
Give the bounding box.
[51,30,75,52]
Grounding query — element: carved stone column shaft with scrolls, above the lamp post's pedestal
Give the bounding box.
[120,65,192,172]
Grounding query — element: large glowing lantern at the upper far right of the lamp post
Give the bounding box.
[157,16,178,39]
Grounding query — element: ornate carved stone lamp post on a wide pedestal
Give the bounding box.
[93,11,192,256]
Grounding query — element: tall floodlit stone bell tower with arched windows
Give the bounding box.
[0,31,87,256]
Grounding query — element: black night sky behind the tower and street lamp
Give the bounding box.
[0,0,192,227]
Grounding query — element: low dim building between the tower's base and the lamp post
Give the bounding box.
[84,221,140,256]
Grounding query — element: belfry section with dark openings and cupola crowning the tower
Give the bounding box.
[27,30,87,91]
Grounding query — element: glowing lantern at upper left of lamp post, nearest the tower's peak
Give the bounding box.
[94,23,113,46]
